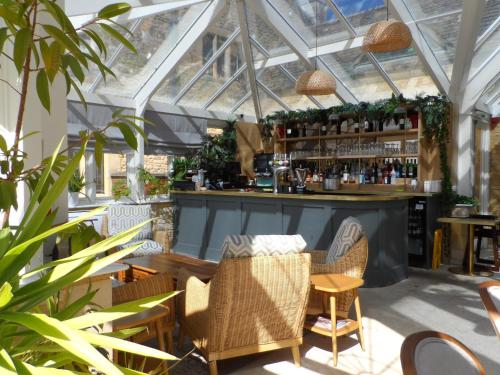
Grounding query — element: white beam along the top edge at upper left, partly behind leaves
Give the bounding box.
[64,0,207,17]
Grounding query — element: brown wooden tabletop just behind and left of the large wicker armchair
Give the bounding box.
[120,254,217,282]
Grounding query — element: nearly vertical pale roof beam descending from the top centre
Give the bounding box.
[236,0,262,119]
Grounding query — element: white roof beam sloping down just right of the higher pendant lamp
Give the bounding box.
[388,0,450,95]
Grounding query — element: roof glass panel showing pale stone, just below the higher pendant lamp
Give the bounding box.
[375,48,439,98]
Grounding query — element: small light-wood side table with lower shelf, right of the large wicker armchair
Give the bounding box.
[304,273,365,366]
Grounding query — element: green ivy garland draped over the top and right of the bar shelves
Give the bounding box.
[260,95,456,214]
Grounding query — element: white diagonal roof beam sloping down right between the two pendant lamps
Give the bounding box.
[247,0,358,103]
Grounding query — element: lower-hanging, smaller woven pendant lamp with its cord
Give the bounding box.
[295,0,337,96]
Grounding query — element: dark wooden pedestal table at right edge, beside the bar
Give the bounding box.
[437,217,500,276]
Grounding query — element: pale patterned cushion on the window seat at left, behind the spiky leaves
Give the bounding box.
[108,204,153,241]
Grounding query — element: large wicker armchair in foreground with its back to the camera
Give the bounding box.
[177,254,311,375]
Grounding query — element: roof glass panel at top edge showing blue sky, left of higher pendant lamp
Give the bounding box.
[273,0,349,47]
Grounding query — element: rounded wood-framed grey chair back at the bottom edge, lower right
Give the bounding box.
[401,331,486,375]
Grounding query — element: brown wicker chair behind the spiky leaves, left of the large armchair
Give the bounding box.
[112,273,175,353]
